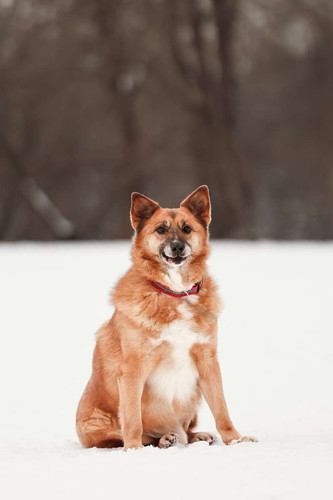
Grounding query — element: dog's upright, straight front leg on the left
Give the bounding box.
[117,360,145,450]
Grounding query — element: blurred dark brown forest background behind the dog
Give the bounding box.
[0,0,333,240]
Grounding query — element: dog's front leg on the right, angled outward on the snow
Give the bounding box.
[193,346,256,444]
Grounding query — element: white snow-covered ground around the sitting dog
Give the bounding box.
[0,242,333,500]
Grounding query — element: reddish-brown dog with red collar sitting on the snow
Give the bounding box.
[76,186,255,450]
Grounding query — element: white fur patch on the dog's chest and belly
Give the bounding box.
[147,303,207,403]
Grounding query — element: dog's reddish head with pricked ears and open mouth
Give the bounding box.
[131,186,211,271]
